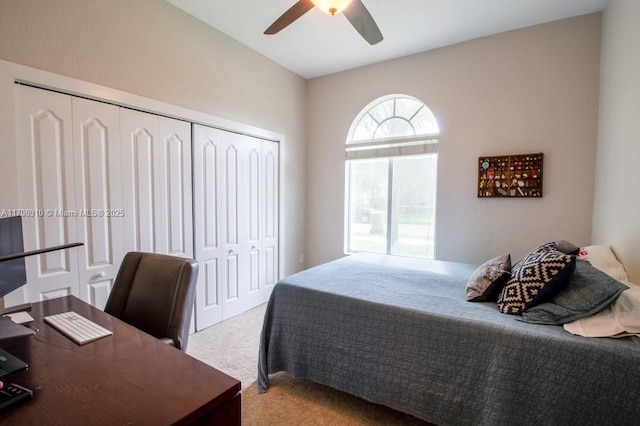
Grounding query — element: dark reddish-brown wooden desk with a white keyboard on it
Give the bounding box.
[0,296,241,425]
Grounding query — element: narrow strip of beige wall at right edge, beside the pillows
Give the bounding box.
[593,0,640,282]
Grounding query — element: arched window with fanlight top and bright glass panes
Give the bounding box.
[345,95,440,259]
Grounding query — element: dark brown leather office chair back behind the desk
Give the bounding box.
[104,252,198,352]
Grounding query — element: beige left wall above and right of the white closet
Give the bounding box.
[0,0,306,274]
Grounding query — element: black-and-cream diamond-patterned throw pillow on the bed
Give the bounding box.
[498,243,576,315]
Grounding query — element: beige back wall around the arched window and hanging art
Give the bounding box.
[306,14,601,266]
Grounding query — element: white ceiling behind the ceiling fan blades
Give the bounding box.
[167,0,607,78]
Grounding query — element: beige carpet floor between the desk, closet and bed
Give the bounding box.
[187,304,428,426]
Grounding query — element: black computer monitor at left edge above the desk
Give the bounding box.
[0,216,27,297]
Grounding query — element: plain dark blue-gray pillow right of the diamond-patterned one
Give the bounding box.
[522,260,629,325]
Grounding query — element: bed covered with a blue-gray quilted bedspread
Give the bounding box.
[257,254,640,426]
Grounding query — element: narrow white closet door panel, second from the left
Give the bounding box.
[72,98,125,309]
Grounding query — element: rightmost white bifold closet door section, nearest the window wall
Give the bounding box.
[193,125,279,330]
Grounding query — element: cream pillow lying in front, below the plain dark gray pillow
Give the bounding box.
[563,284,640,337]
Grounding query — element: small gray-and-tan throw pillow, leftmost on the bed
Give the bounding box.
[466,254,511,302]
